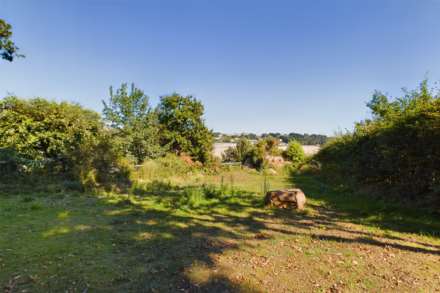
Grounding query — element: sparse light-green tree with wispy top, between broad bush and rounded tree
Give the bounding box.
[103,83,162,163]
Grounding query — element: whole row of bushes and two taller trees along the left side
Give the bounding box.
[0,84,213,187]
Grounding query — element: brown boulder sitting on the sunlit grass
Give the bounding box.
[265,188,306,210]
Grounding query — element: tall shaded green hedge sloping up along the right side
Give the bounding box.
[316,81,440,203]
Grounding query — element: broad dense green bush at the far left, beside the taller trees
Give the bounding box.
[0,97,131,187]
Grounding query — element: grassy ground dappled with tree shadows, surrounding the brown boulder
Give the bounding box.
[0,170,440,292]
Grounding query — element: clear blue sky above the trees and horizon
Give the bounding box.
[0,0,440,134]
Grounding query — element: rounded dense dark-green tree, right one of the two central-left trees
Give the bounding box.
[157,93,213,163]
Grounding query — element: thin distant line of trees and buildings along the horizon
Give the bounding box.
[214,132,328,145]
